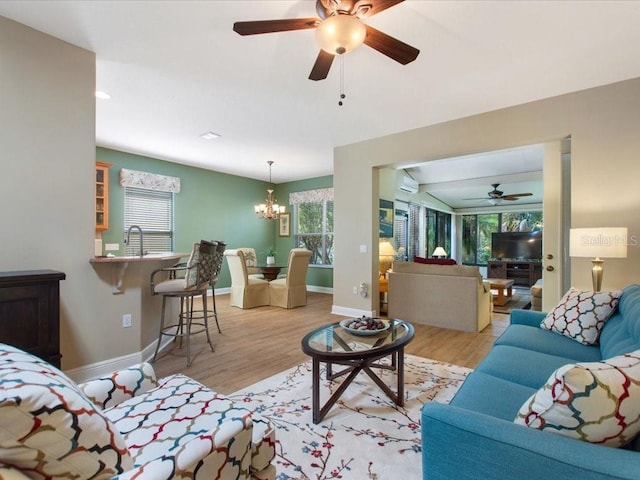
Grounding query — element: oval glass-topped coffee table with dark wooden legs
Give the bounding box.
[302,319,414,423]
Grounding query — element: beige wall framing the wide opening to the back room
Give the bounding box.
[333,79,640,312]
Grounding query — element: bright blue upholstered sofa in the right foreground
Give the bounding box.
[422,285,640,480]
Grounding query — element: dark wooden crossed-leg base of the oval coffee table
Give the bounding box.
[312,348,404,423]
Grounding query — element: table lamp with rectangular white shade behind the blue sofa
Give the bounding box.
[569,227,627,292]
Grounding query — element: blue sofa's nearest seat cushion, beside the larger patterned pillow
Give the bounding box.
[451,371,537,422]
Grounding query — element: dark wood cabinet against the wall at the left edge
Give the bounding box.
[0,270,66,367]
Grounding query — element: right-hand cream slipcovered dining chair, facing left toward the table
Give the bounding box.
[269,248,311,308]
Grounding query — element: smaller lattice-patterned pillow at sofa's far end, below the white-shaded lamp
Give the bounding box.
[540,288,622,345]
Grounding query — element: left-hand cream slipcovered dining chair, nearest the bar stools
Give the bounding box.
[224,249,269,308]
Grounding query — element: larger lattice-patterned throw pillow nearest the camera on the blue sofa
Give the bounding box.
[514,350,640,447]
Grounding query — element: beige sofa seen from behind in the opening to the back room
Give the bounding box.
[388,262,493,332]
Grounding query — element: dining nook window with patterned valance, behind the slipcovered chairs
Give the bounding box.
[289,188,334,265]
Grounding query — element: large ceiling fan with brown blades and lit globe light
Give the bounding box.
[233,0,420,80]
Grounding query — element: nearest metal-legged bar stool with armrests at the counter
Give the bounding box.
[151,240,218,367]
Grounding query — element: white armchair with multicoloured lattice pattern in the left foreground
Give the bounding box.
[0,344,276,480]
